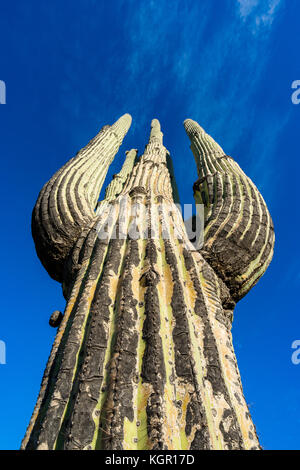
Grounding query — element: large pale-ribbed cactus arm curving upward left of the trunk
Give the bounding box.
[32,114,131,282]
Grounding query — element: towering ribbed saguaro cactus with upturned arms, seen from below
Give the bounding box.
[22,115,274,450]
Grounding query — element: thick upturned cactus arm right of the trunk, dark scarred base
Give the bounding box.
[184,119,274,301]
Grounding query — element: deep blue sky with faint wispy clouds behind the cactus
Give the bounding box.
[0,0,300,449]
